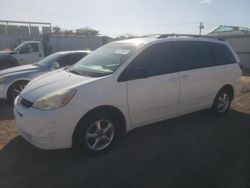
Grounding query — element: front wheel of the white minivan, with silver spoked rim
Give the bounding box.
[74,112,120,155]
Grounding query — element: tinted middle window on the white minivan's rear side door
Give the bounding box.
[174,41,213,71]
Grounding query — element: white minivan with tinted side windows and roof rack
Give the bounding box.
[14,35,242,154]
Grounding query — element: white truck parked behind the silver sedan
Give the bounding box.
[0,41,44,70]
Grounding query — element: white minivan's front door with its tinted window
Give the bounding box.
[123,43,180,126]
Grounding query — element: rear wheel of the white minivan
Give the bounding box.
[211,89,232,116]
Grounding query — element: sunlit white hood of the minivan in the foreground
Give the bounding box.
[20,69,98,101]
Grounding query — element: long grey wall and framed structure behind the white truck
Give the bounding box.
[0,20,108,55]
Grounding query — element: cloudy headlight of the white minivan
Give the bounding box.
[33,89,76,110]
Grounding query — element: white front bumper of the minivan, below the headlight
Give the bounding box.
[14,98,88,149]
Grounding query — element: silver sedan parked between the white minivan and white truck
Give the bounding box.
[0,51,90,101]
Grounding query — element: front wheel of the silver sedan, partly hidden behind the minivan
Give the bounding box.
[7,81,29,103]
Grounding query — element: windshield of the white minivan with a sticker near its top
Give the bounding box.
[70,43,138,77]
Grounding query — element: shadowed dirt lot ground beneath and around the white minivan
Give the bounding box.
[0,77,250,188]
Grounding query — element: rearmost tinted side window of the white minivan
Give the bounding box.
[209,43,236,65]
